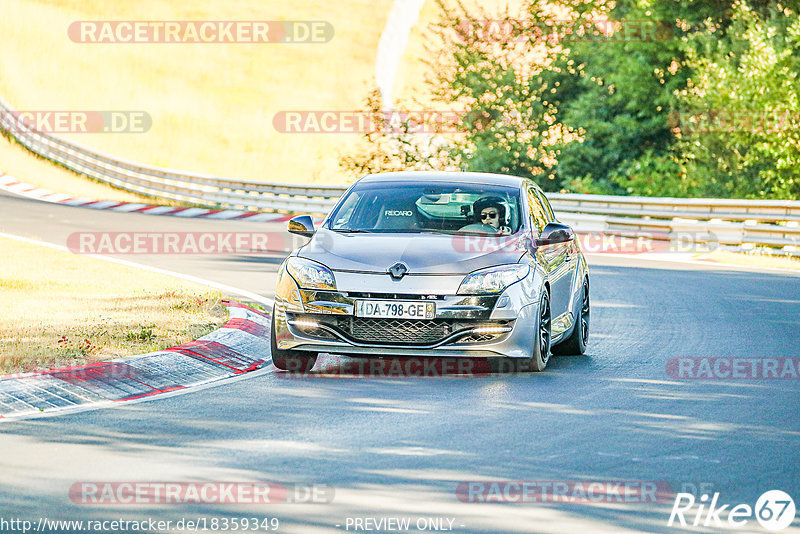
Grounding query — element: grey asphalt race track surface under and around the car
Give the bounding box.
[0,194,800,533]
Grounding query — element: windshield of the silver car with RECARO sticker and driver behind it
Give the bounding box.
[328,182,521,235]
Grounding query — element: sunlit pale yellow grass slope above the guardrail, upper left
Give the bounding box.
[0,0,391,185]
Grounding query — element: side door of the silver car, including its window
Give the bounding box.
[528,186,570,336]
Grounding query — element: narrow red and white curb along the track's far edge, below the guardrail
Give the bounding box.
[0,173,292,222]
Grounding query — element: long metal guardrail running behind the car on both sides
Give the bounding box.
[0,98,800,255]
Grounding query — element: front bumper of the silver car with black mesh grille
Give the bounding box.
[275,269,538,358]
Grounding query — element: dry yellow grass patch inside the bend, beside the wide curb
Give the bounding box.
[0,238,227,374]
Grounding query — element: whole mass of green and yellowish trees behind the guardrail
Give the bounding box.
[344,0,800,198]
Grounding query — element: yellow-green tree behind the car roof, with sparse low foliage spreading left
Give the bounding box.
[342,0,559,190]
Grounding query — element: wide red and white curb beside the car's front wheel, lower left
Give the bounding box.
[0,301,271,419]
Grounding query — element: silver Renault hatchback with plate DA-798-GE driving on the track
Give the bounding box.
[271,172,589,372]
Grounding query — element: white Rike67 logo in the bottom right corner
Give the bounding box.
[667,490,795,532]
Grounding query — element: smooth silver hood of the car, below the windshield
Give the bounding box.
[298,228,526,274]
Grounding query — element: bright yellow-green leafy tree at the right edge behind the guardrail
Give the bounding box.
[677,2,800,199]
